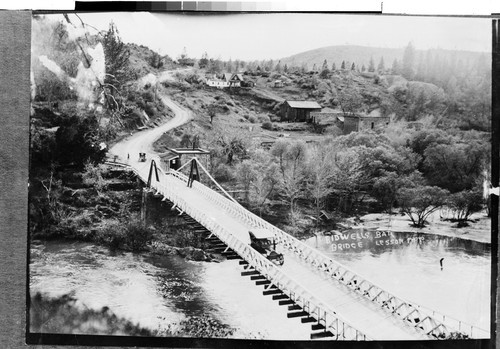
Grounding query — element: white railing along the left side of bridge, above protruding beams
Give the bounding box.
[152,173,371,340]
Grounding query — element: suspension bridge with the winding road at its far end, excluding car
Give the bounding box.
[110,91,489,340]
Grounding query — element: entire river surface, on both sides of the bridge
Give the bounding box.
[30,228,490,340]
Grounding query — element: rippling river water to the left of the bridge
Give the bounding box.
[30,241,310,340]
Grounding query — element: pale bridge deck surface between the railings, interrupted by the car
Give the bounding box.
[140,165,428,340]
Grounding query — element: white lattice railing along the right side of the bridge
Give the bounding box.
[165,171,489,338]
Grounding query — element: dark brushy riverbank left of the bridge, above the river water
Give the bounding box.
[29,158,218,261]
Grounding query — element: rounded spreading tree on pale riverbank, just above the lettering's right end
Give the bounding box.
[397,185,449,228]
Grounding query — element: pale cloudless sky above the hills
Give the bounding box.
[71,12,491,60]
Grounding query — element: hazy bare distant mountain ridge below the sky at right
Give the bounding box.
[281,45,489,69]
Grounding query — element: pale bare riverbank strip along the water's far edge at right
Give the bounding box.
[356,211,491,243]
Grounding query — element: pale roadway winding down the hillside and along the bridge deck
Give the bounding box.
[109,72,488,340]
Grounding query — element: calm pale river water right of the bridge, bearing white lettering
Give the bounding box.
[307,230,491,329]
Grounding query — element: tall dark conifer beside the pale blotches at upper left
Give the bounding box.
[102,22,130,88]
